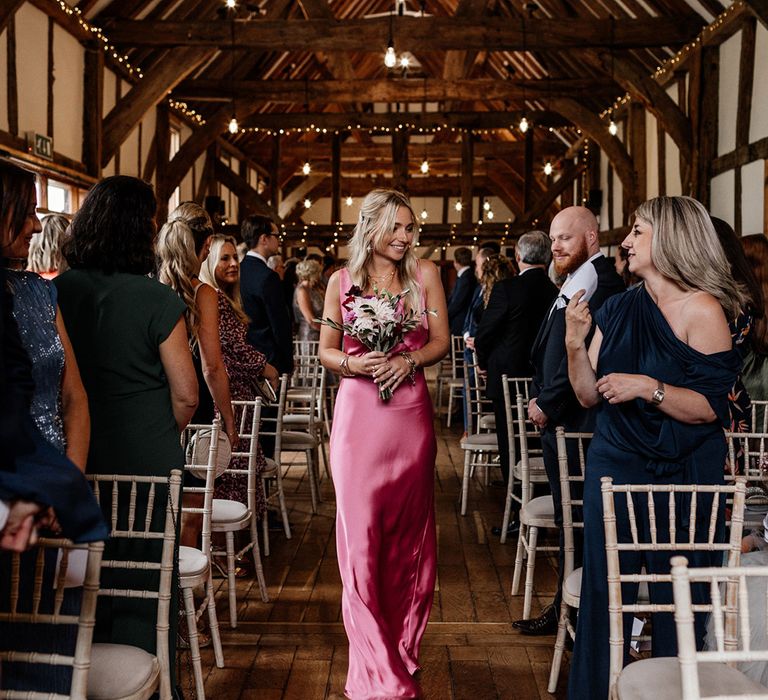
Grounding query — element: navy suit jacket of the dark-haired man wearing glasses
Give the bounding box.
[240,255,293,374]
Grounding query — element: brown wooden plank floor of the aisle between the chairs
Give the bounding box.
[196,380,569,700]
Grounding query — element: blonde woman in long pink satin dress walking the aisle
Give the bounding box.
[320,190,449,700]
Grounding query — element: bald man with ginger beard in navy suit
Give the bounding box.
[514,207,624,634]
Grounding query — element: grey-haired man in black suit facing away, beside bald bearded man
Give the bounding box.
[475,231,557,534]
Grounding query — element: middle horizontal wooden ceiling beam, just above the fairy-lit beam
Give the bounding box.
[174,78,616,104]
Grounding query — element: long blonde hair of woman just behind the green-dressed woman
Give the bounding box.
[155,219,200,348]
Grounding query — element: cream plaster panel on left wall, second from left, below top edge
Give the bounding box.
[53,24,85,161]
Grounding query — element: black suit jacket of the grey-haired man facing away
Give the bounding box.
[475,268,557,401]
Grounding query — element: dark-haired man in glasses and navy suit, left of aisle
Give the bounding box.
[240,215,293,374]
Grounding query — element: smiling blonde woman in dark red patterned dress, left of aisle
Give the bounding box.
[200,236,278,508]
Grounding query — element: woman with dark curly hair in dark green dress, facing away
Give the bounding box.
[55,176,197,688]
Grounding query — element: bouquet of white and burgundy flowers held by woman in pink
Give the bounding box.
[316,286,435,401]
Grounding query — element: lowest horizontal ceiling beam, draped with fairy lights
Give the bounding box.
[238,109,571,131]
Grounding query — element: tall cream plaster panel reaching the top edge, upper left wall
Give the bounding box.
[15,3,48,137]
